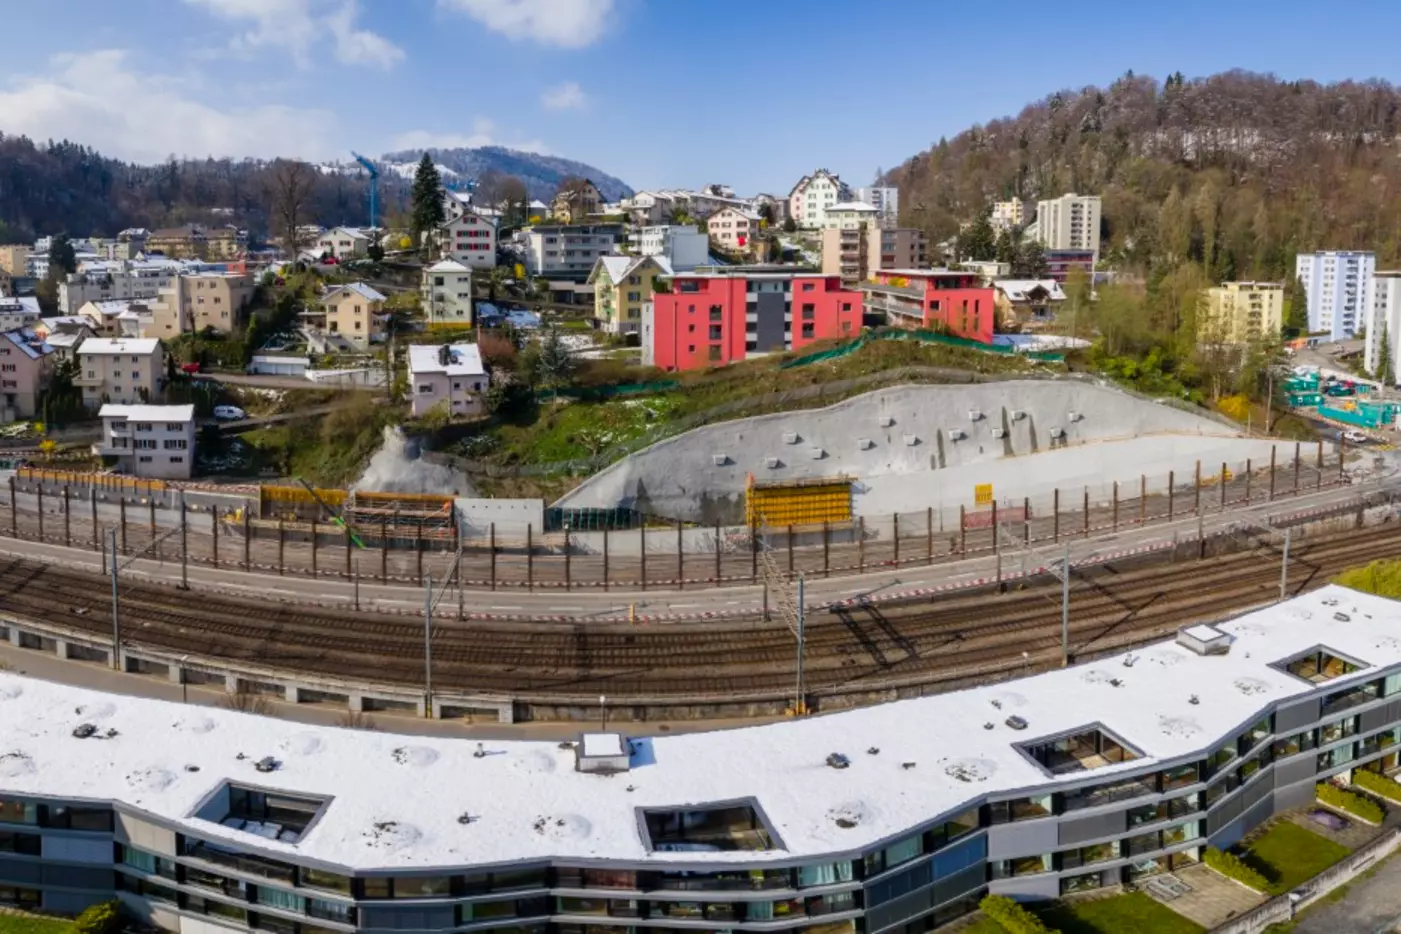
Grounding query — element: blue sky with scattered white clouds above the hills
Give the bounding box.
[8,0,1401,193]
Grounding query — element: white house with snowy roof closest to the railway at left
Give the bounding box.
[92,403,195,480]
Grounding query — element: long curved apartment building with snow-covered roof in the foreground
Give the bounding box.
[0,588,1401,934]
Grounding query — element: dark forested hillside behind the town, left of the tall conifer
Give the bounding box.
[0,137,392,242]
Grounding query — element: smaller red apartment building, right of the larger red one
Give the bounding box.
[862,269,998,343]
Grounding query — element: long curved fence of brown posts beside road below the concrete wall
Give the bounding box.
[0,445,1348,591]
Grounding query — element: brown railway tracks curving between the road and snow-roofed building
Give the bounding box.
[0,527,1401,702]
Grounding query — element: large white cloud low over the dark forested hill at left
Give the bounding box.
[0,49,336,162]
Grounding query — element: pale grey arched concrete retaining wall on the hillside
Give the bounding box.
[556,379,1266,524]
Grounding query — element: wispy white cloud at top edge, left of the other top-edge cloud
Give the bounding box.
[185,0,403,69]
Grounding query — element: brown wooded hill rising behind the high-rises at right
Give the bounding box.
[885,71,1401,280]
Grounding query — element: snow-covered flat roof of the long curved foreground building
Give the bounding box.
[0,587,1401,871]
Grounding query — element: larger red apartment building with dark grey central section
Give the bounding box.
[642,266,863,371]
